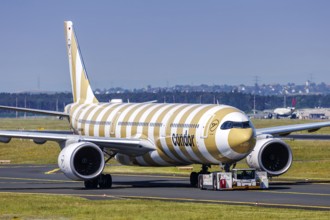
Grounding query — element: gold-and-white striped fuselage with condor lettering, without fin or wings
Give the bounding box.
[67,103,255,166]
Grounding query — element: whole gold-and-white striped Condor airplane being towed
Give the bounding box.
[0,21,330,189]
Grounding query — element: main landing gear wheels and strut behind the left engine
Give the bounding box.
[84,151,116,189]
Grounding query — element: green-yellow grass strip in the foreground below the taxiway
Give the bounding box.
[0,193,330,220]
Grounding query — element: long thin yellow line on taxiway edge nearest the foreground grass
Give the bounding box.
[0,192,330,211]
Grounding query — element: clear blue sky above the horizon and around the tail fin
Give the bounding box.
[0,0,330,92]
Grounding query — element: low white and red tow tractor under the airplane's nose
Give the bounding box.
[198,169,269,190]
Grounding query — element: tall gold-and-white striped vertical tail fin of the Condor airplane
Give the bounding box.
[64,21,98,104]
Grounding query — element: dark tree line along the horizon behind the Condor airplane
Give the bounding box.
[0,91,330,117]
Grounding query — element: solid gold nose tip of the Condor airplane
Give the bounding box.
[228,128,256,154]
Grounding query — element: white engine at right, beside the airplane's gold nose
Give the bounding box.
[246,138,292,176]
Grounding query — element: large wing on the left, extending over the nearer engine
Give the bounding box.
[0,130,155,156]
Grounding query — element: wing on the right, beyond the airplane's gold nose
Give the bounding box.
[256,122,330,136]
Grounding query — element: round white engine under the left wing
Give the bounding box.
[58,142,104,180]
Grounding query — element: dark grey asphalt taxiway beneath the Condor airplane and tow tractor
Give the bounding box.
[0,165,330,211]
